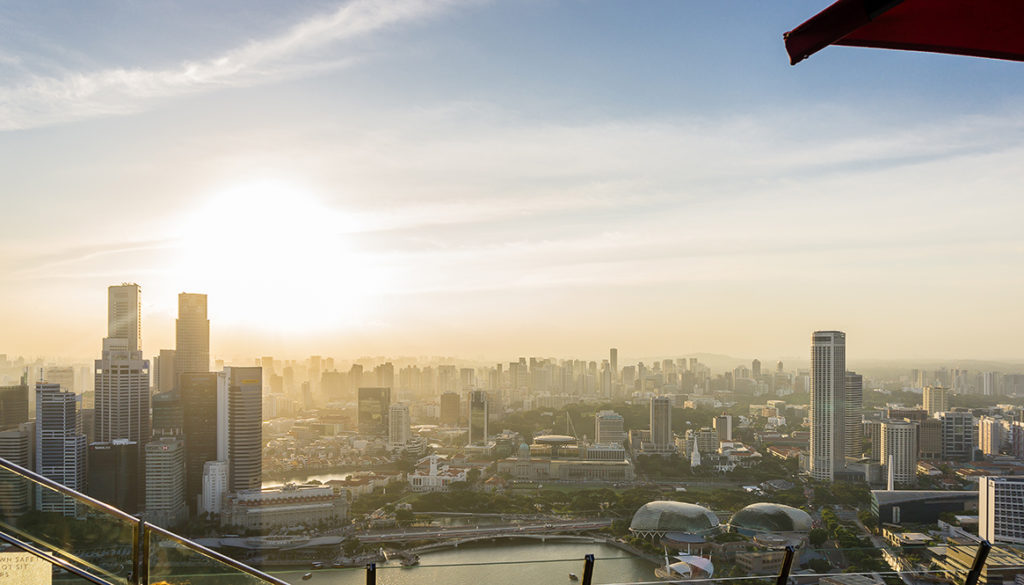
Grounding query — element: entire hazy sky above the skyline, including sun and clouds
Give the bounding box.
[0,0,1024,359]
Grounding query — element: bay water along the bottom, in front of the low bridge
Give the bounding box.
[273,541,656,585]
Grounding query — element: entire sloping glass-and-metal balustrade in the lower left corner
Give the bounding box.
[0,459,289,585]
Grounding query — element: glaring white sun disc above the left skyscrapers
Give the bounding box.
[174,180,369,332]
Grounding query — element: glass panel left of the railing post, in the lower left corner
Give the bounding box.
[0,467,136,584]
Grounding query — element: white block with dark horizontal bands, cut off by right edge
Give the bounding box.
[978,475,1024,544]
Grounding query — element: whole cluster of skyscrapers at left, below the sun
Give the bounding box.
[0,284,262,526]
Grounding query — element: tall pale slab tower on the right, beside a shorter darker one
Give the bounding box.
[810,331,846,482]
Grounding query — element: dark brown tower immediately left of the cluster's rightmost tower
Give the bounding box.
[180,372,218,514]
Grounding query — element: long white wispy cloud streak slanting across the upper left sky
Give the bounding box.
[0,0,468,131]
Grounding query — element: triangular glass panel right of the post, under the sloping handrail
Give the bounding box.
[148,532,282,585]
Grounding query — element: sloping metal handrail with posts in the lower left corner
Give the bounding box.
[0,458,289,585]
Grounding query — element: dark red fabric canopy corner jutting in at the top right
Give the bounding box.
[783,0,1024,65]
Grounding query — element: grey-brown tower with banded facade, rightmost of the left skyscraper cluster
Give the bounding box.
[218,366,263,492]
